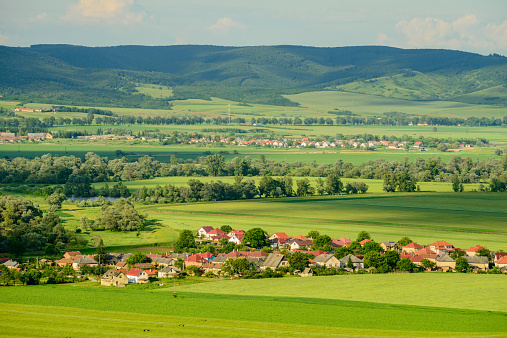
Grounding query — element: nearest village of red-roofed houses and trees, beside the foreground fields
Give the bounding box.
[0,226,507,287]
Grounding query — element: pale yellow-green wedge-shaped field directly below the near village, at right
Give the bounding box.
[174,273,507,313]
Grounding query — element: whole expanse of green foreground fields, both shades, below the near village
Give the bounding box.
[0,274,507,337]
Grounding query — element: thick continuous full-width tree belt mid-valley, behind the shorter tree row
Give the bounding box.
[0,153,507,186]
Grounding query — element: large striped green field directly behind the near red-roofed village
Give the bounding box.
[62,193,507,251]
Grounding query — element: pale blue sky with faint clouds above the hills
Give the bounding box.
[0,0,507,56]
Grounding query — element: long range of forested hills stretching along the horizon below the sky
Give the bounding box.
[0,45,507,108]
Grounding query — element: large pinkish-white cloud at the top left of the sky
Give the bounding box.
[62,0,148,25]
